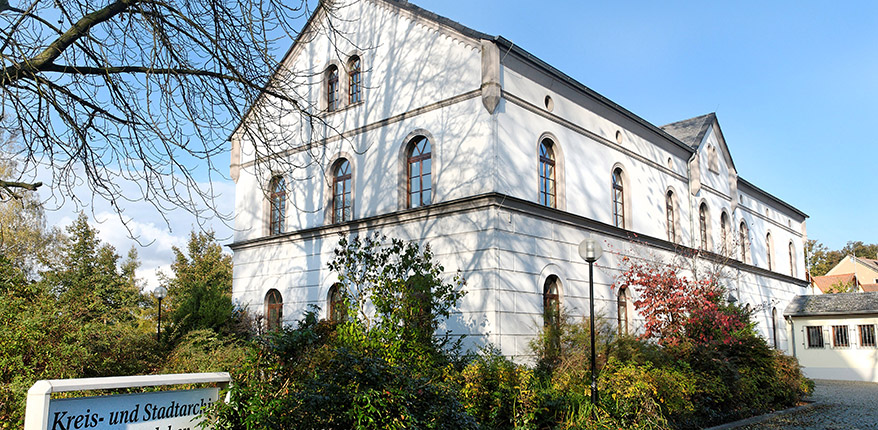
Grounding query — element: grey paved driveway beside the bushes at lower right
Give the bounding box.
[740,380,878,430]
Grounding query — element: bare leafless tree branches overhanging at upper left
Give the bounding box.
[0,0,343,227]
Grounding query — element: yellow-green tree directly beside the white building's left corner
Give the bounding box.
[160,232,241,339]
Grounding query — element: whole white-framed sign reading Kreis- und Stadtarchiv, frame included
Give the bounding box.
[24,372,231,430]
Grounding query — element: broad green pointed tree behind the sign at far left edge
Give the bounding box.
[0,215,158,428]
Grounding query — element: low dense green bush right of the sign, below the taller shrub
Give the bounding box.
[211,312,476,429]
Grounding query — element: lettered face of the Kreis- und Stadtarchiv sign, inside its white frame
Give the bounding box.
[47,388,219,430]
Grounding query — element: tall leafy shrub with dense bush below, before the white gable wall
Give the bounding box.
[214,236,476,429]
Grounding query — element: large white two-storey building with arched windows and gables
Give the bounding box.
[231,0,808,356]
